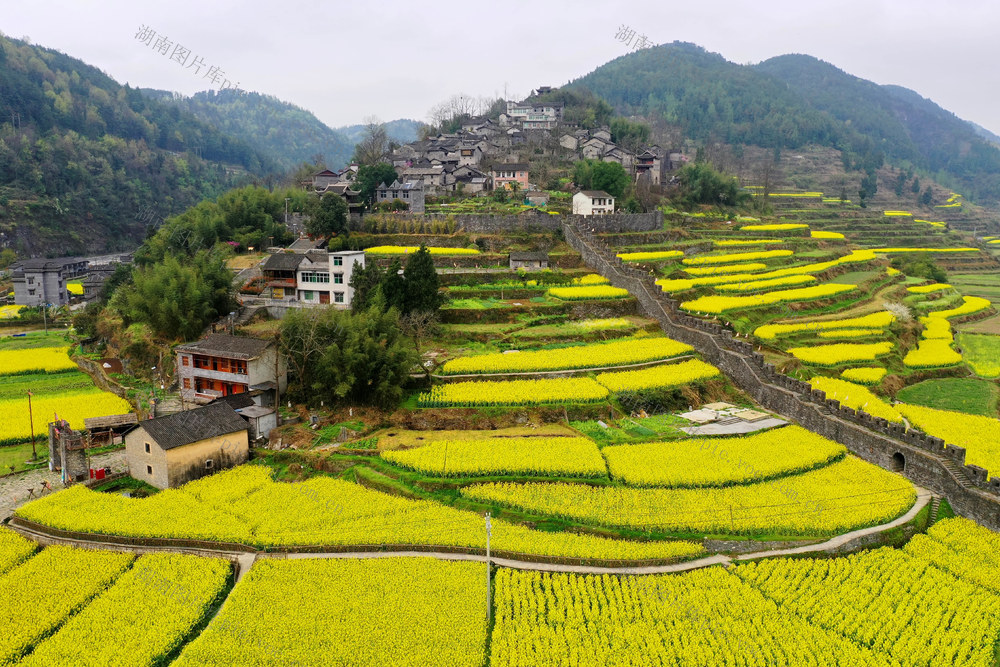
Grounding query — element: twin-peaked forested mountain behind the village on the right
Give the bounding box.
[569,42,1000,202]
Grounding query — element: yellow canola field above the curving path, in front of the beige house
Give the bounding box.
[16,465,702,560]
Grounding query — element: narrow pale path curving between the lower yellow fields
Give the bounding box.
[9,487,932,581]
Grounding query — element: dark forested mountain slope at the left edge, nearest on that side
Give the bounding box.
[0,36,277,257]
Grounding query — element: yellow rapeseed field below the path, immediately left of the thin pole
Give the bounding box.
[173,558,486,667]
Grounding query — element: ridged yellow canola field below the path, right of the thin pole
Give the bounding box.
[490,519,1000,667]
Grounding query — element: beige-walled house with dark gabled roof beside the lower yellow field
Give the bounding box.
[124,402,250,489]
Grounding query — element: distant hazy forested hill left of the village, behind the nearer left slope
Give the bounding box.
[142,88,356,171]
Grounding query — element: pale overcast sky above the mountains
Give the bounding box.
[0,0,1000,134]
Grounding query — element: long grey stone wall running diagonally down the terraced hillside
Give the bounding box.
[563,224,1000,530]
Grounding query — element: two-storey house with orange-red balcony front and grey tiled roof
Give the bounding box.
[175,334,288,403]
